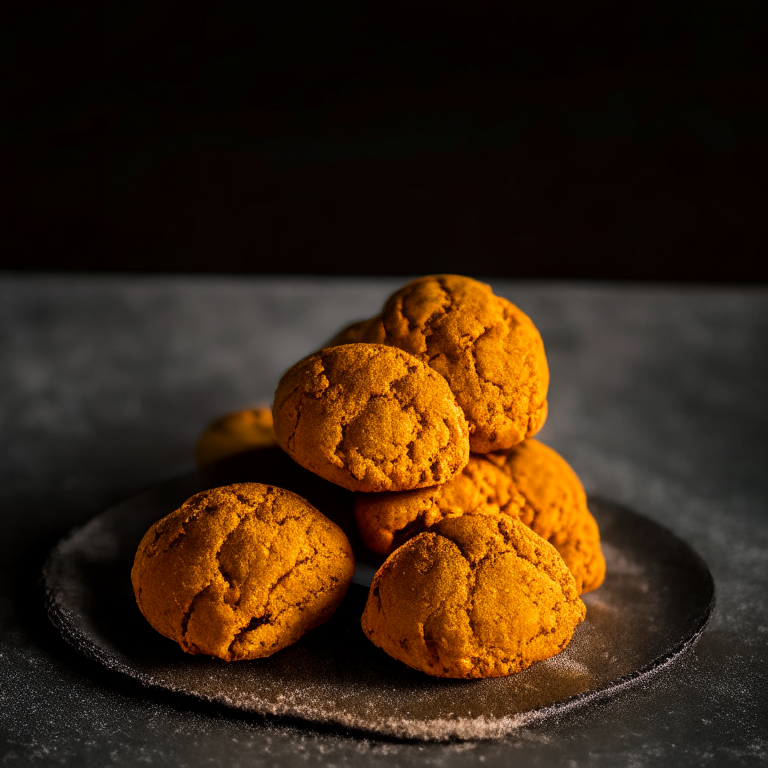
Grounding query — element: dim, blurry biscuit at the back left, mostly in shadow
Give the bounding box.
[195,408,277,466]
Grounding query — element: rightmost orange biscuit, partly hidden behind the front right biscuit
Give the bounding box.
[486,440,605,592]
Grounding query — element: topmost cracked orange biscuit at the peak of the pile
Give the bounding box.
[365,275,549,453]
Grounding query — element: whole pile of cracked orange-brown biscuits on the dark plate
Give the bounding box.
[134,275,605,678]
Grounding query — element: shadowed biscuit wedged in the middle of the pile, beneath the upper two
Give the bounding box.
[355,455,525,555]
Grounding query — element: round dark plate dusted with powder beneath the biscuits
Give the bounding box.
[44,449,714,739]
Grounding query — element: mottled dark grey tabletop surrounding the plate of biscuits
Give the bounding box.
[0,276,768,766]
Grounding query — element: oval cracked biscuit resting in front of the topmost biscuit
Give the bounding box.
[273,344,469,492]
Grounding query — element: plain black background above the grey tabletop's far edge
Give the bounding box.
[2,0,768,282]
